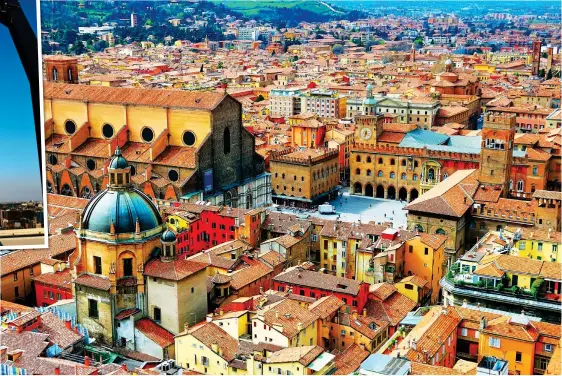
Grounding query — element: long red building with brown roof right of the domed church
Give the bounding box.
[273,266,369,312]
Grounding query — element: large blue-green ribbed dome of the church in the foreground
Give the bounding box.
[82,188,162,234]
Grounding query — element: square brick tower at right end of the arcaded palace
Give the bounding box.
[480,113,515,197]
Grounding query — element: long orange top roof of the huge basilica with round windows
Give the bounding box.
[43,82,225,111]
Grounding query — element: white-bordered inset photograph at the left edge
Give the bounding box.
[0,0,47,250]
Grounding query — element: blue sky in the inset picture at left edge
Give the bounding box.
[0,0,42,202]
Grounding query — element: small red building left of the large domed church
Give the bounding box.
[33,266,72,307]
